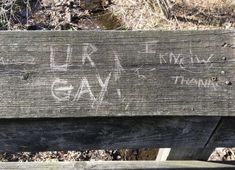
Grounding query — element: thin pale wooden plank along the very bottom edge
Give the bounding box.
[0,161,235,170]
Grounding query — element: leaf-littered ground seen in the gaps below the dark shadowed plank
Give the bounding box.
[0,148,235,162]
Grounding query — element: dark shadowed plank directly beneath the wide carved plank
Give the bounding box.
[0,117,219,152]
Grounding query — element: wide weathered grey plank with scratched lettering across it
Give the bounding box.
[0,30,235,118]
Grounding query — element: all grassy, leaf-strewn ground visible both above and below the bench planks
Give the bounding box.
[0,0,235,162]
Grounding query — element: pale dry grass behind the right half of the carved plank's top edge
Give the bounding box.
[111,0,235,30]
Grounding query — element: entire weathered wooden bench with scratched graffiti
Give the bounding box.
[0,30,235,169]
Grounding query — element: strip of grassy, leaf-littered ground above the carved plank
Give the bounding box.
[0,0,235,30]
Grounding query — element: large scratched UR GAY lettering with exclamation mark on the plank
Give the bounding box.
[50,43,119,110]
